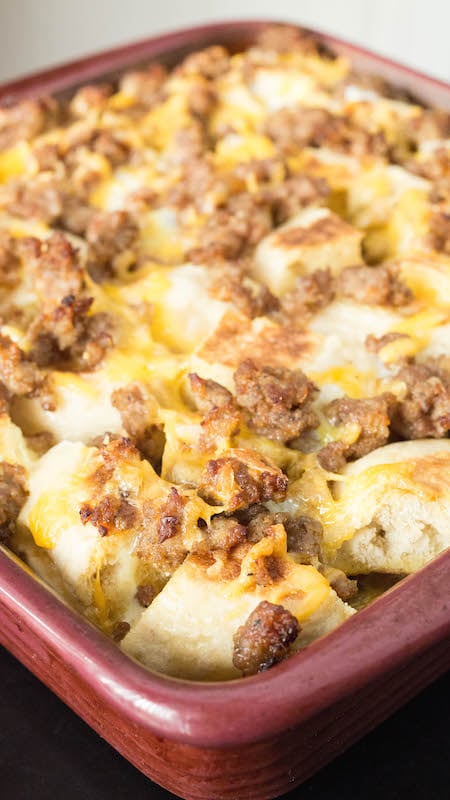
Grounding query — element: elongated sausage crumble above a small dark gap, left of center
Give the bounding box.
[111,383,165,470]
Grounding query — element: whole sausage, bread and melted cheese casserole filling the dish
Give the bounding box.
[0,26,450,680]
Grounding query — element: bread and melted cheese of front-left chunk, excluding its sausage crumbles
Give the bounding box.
[19,441,217,629]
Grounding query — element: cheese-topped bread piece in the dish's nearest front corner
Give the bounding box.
[122,525,353,680]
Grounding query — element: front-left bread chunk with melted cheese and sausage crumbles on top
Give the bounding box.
[19,436,220,631]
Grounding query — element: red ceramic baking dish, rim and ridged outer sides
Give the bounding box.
[0,21,450,800]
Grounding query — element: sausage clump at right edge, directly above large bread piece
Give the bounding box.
[392,356,450,439]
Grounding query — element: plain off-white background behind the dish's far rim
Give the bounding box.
[0,0,450,81]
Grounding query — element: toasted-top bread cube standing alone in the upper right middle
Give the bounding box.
[253,207,363,295]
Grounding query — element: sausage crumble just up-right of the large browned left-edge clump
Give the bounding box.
[86,211,139,280]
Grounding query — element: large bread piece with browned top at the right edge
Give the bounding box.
[324,439,450,574]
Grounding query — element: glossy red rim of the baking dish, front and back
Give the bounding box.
[0,20,450,748]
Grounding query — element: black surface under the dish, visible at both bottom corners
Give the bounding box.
[0,650,450,800]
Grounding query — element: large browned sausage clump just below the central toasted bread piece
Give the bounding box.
[234,359,319,442]
